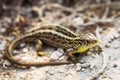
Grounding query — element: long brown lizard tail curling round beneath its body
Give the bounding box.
[5,34,71,68]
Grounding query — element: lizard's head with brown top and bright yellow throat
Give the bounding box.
[77,34,99,53]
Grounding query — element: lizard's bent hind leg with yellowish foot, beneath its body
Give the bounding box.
[36,39,50,57]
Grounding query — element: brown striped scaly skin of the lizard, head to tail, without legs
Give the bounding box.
[5,24,98,67]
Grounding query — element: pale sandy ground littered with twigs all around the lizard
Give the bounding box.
[0,0,120,80]
